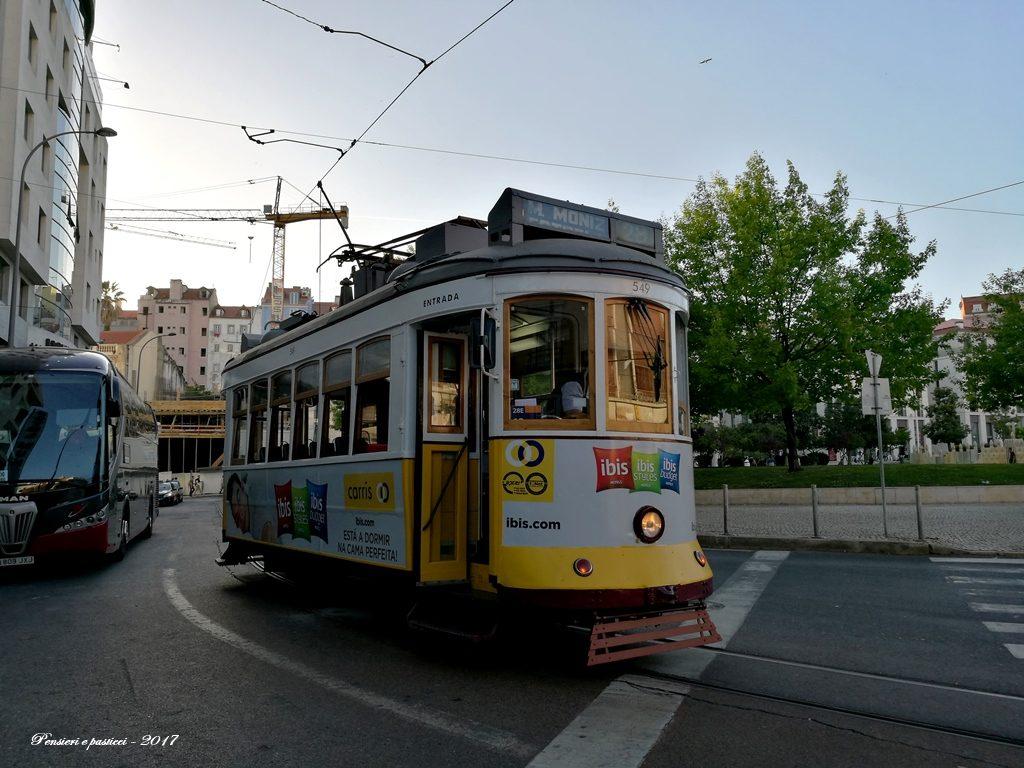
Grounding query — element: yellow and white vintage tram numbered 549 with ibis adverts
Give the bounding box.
[222,189,718,664]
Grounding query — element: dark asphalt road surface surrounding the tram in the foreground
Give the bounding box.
[0,500,1024,768]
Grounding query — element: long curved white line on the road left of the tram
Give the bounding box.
[164,568,537,758]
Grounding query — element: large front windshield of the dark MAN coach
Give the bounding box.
[0,372,103,486]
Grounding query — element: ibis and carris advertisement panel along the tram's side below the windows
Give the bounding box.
[224,461,411,569]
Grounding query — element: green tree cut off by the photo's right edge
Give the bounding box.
[957,269,1024,411]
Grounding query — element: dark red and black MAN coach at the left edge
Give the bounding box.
[0,347,158,566]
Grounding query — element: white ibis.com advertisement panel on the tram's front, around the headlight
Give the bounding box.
[492,438,696,547]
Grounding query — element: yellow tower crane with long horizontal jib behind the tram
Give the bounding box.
[106,176,348,323]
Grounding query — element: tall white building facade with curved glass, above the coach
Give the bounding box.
[0,0,108,347]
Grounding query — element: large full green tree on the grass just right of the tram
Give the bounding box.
[666,154,943,471]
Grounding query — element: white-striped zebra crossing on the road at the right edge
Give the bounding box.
[931,557,1024,659]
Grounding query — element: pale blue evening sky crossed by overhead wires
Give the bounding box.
[94,0,1024,316]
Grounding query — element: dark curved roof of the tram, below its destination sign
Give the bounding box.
[224,238,686,371]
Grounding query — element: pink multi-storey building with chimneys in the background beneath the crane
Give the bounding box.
[138,280,217,387]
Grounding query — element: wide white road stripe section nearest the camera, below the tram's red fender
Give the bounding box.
[527,679,689,768]
